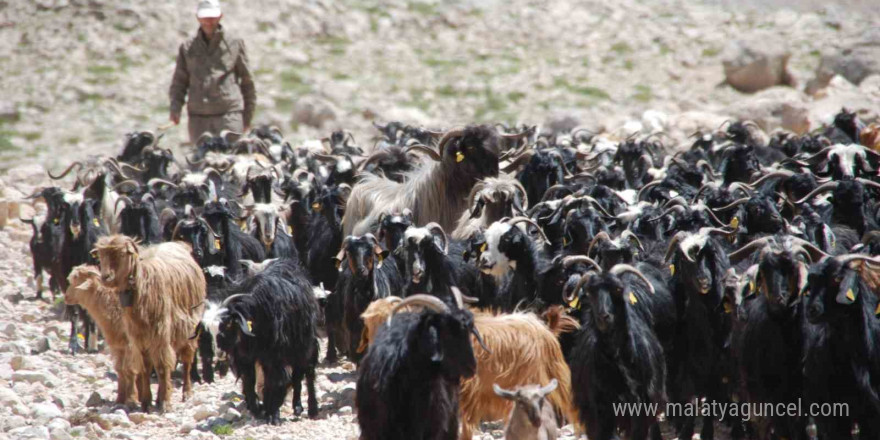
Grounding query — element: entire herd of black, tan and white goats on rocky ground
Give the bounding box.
[18,109,880,440]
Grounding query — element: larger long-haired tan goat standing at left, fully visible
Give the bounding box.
[95,235,206,411]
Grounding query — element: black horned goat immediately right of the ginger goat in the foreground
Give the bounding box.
[570,265,667,440]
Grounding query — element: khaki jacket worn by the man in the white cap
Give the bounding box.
[169,27,257,126]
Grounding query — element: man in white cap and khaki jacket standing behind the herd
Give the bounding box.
[169,0,257,143]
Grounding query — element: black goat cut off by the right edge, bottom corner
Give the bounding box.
[804,254,880,439]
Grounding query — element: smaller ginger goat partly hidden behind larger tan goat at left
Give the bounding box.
[64,265,138,405]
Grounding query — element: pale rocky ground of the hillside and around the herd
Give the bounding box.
[0,0,880,439]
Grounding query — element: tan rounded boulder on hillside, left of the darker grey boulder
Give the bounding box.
[722,36,795,93]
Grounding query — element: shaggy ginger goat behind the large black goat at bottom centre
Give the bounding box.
[358,297,578,440]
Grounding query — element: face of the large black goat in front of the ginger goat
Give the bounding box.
[419,310,477,378]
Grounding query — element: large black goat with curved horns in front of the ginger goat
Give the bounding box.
[355,294,482,440]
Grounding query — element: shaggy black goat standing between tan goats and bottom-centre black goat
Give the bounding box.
[217,259,318,425]
